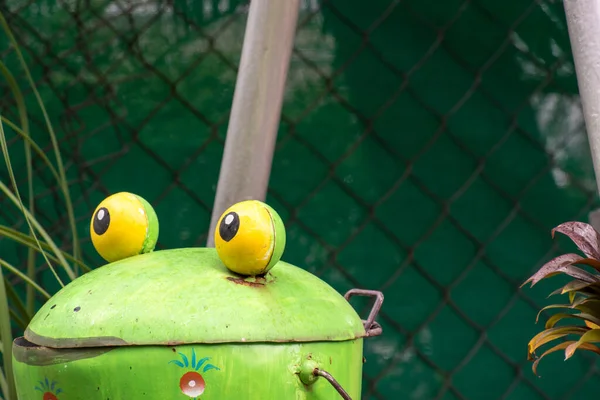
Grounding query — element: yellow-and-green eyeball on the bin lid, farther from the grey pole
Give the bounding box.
[90,192,158,262]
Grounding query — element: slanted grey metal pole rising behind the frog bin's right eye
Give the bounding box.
[207,0,300,247]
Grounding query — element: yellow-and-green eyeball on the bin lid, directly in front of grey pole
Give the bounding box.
[215,200,285,276]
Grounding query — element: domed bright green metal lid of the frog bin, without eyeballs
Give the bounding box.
[24,248,366,348]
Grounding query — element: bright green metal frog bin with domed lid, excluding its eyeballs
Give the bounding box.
[13,248,383,400]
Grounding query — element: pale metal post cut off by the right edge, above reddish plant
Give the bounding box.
[564,0,600,197]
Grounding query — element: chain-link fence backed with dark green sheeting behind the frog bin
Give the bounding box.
[0,0,600,400]
